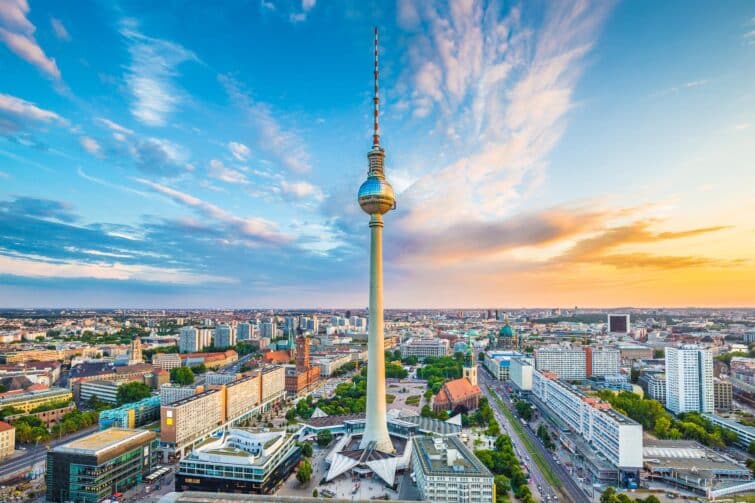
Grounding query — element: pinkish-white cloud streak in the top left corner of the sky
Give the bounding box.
[0,0,60,80]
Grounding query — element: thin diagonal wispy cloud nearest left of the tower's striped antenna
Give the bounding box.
[218,75,311,173]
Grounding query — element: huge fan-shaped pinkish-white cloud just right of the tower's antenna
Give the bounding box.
[396,0,610,238]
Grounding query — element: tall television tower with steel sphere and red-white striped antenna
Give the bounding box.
[358,28,396,452]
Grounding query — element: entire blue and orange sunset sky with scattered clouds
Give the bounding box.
[0,0,755,307]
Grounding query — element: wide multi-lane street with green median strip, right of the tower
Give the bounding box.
[478,366,590,503]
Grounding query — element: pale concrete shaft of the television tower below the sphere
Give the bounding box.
[360,214,393,452]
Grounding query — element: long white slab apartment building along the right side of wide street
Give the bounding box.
[532,371,642,473]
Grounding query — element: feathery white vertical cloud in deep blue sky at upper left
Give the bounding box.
[121,20,197,126]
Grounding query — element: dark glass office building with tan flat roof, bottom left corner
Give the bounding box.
[46,428,158,503]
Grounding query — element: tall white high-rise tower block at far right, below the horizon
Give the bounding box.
[666,345,714,414]
